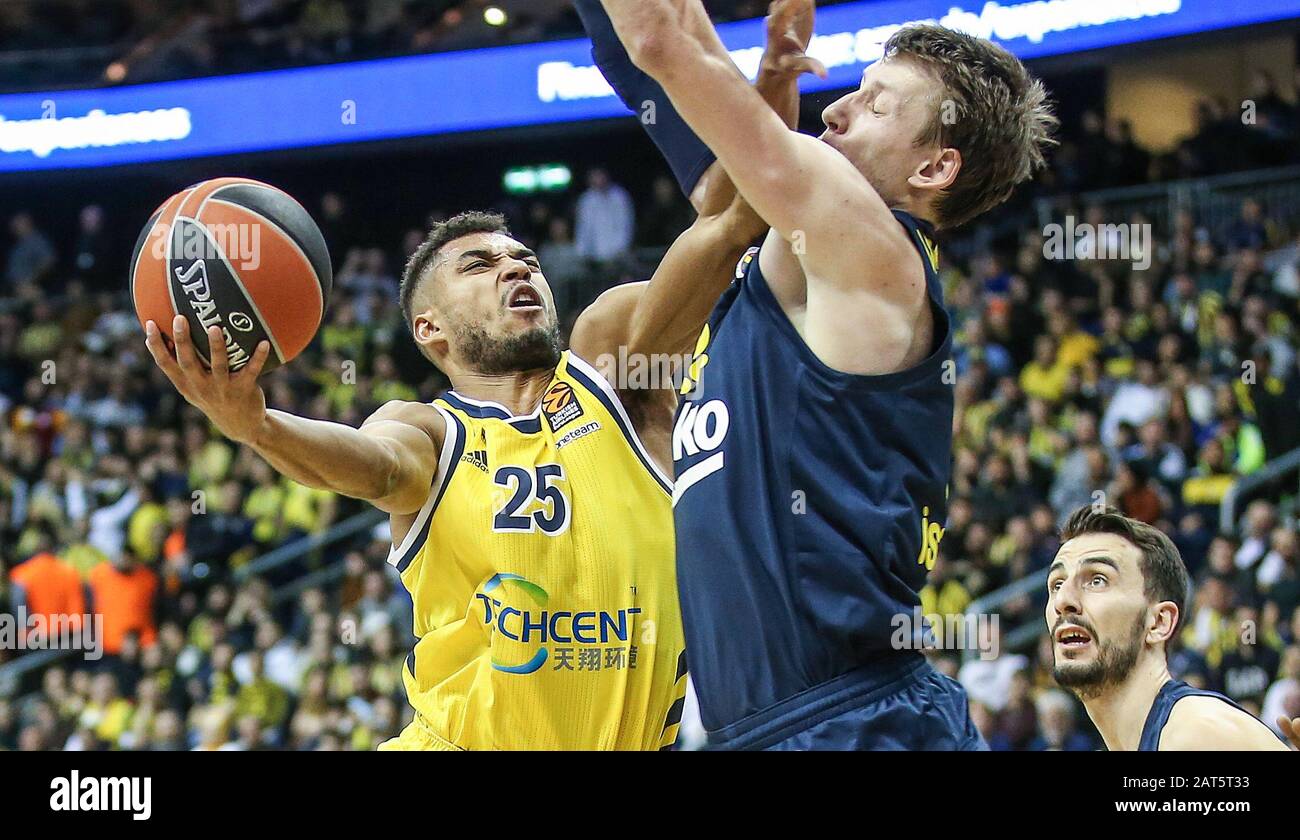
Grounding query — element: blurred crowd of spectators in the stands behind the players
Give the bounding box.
[0,34,1300,749]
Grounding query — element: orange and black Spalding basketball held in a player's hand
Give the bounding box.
[131,178,333,371]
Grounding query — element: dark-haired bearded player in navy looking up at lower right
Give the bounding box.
[1047,506,1300,750]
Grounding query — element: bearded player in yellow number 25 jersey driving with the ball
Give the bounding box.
[146,4,810,750]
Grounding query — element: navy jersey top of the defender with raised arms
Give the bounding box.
[672,211,953,731]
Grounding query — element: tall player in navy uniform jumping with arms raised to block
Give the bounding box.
[590,0,1056,749]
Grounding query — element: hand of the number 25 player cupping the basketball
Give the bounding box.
[144,315,270,443]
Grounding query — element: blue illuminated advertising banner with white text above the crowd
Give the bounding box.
[0,0,1300,172]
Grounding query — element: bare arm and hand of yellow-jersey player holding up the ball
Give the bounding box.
[146,316,446,514]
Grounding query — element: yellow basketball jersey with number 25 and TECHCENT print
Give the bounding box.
[389,352,685,749]
